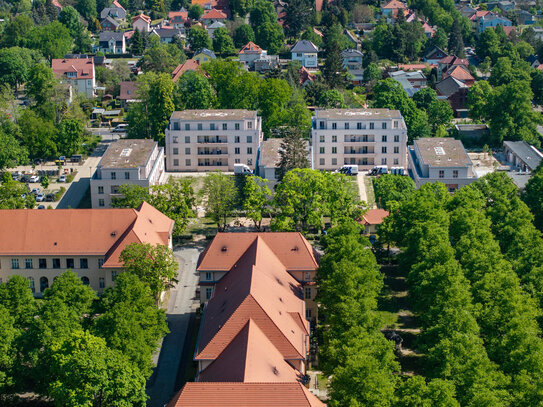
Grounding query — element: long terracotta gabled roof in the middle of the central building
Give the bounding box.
[195,237,309,360]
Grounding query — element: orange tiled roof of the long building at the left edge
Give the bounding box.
[0,202,173,267]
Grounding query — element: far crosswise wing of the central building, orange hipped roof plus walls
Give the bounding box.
[196,232,319,320]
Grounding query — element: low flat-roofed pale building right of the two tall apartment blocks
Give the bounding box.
[408,137,477,192]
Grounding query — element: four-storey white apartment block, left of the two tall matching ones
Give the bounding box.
[166,109,263,171]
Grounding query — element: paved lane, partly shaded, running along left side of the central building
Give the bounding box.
[147,245,203,407]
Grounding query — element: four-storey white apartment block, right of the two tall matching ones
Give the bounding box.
[311,109,407,170]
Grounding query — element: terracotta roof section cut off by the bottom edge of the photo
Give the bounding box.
[167,382,325,407]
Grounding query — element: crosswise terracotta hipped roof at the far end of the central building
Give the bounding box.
[198,232,318,271]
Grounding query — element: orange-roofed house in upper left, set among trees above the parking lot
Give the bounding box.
[51,58,96,98]
